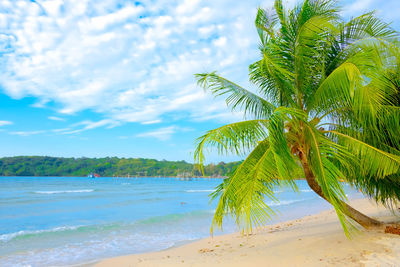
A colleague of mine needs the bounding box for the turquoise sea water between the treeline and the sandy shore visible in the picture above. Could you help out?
[0,177,360,266]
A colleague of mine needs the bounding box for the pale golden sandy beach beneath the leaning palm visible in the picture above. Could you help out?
[94,199,400,267]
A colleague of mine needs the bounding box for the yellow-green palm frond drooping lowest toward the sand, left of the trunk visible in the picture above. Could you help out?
[211,139,279,233]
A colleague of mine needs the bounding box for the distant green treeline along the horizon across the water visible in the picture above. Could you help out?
[0,156,240,177]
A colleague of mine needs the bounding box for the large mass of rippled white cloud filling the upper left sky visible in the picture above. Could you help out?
[0,0,259,127]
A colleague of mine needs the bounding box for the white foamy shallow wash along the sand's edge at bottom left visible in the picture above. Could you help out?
[0,230,195,266]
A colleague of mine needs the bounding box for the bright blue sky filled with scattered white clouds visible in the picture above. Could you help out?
[0,0,400,162]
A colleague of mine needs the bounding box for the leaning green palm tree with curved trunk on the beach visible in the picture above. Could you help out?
[195,0,400,234]
